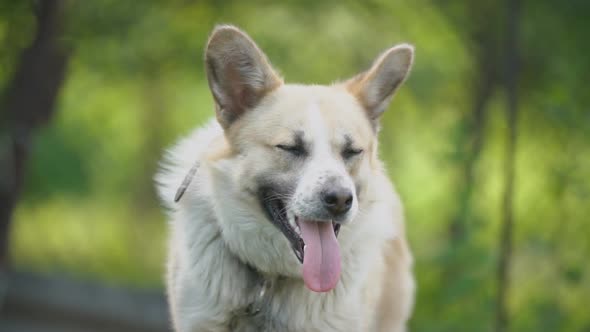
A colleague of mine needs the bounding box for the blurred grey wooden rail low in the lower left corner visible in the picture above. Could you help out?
[0,272,170,332]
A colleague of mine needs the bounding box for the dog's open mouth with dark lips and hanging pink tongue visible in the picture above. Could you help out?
[260,190,341,292]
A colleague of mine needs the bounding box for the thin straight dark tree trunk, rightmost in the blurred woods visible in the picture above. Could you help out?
[496,0,520,332]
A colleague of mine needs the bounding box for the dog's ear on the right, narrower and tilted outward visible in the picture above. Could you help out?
[345,44,414,126]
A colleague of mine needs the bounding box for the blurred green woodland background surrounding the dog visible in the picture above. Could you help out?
[0,0,590,332]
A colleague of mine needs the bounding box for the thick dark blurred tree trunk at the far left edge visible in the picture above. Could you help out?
[0,0,68,271]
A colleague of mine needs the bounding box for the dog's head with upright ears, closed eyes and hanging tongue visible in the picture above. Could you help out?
[205,26,413,291]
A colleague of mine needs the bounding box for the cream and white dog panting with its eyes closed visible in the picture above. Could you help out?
[156,25,415,332]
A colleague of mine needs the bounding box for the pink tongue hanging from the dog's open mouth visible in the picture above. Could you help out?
[299,220,340,292]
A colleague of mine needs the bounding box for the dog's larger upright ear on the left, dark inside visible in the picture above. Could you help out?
[205,25,283,128]
